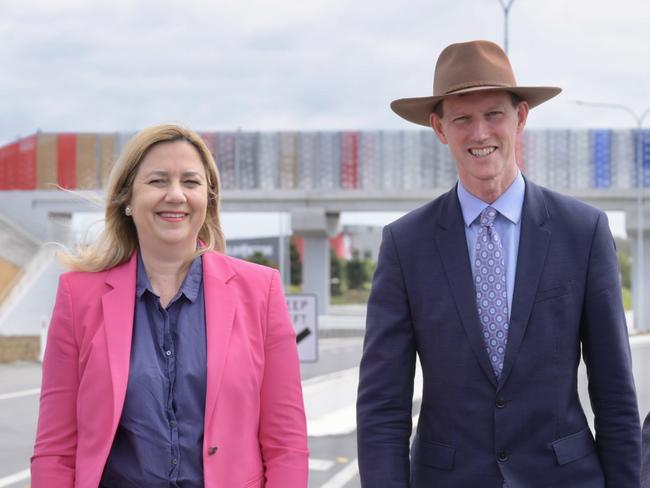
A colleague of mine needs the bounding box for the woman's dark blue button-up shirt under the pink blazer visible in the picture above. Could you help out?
[100,254,207,488]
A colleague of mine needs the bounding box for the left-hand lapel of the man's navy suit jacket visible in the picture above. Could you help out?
[436,188,496,387]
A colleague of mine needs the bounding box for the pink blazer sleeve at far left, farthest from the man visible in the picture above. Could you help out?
[31,274,79,488]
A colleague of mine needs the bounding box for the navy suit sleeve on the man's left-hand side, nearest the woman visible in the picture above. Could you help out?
[357,226,416,488]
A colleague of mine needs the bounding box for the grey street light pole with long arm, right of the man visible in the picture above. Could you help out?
[573,100,650,330]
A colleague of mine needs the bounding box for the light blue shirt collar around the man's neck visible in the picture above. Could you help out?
[457,171,526,227]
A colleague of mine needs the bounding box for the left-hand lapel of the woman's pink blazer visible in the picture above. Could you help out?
[102,252,137,427]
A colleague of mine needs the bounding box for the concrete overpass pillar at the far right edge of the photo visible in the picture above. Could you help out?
[625,208,650,331]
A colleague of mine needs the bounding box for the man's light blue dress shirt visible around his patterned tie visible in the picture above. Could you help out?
[457,172,526,316]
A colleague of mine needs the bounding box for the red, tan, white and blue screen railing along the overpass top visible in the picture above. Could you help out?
[0,129,650,191]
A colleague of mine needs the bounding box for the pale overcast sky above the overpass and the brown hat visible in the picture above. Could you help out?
[0,0,650,144]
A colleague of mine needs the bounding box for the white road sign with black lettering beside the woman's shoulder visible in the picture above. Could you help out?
[286,294,318,363]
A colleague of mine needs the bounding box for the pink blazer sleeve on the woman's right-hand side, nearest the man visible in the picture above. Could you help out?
[259,271,309,488]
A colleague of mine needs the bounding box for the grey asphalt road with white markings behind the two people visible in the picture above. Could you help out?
[0,332,650,488]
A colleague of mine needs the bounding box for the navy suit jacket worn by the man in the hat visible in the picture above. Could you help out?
[357,180,641,488]
